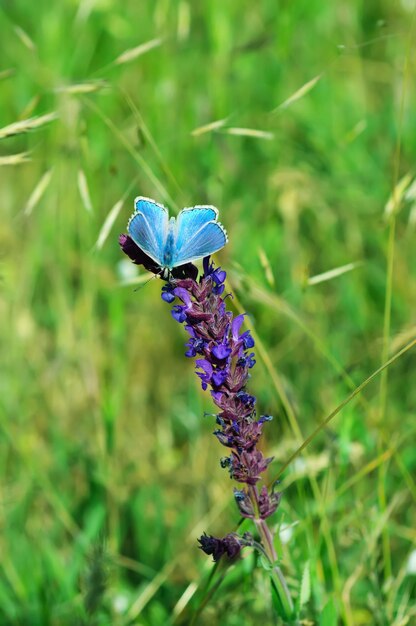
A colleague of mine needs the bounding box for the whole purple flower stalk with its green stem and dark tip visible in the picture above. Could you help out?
[119,235,297,624]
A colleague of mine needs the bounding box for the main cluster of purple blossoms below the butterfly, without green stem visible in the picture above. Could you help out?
[164,259,277,508]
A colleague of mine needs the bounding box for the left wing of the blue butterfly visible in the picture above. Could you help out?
[127,196,169,266]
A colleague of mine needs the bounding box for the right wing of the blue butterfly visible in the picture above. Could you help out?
[172,206,228,267]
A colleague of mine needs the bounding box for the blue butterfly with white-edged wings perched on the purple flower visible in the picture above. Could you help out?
[127,196,228,271]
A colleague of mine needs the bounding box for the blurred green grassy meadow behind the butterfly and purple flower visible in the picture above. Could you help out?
[0,0,416,626]
